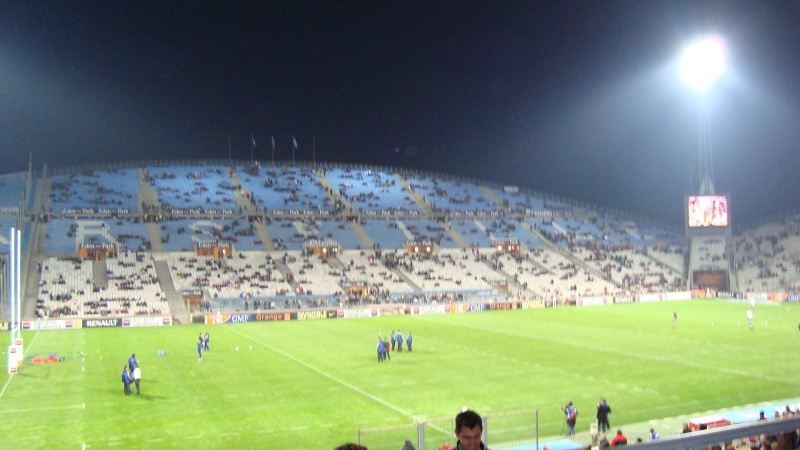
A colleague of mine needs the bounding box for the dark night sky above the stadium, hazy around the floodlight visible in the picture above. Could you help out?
[0,0,800,225]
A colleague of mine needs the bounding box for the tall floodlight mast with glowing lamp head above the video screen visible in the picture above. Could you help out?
[680,36,725,195]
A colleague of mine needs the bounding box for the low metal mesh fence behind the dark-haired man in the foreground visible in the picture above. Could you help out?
[358,409,539,450]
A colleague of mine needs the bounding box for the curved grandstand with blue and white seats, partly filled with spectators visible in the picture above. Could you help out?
[0,161,800,323]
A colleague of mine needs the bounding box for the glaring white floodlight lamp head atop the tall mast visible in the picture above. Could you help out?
[681,36,725,92]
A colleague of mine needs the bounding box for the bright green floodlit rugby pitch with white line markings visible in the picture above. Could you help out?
[0,300,800,449]
